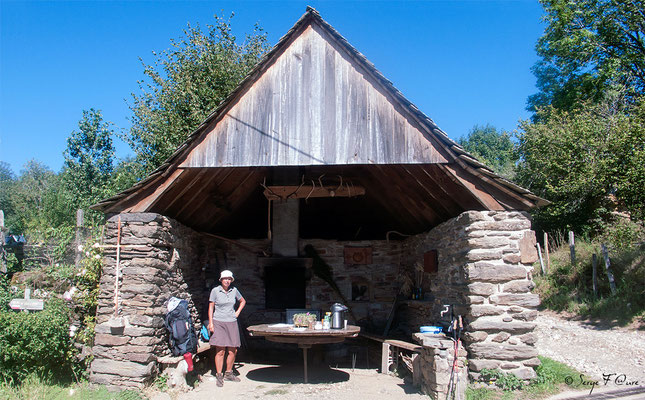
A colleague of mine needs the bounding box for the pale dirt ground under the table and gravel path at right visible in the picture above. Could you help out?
[146,312,645,400]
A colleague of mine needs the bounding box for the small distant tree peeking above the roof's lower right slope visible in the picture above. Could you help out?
[459,124,518,179]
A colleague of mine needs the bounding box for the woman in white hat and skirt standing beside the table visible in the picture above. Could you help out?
[208,270,246,387]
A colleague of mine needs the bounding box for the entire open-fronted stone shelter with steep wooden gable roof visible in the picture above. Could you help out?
[91,8,546,387]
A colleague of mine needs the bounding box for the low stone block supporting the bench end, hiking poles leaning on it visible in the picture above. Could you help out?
[413,333,468,400]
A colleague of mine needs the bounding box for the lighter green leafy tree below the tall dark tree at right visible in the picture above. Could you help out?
[517,94,645,234]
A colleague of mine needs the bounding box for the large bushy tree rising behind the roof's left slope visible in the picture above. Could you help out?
[125,15,268,172]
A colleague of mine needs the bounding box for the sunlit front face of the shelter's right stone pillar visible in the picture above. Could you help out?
[464,211,540,379]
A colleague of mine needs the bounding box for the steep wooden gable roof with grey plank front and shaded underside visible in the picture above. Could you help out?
[93,8,546,236]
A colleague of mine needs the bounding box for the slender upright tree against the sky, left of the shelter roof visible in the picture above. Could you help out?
[60,108,114,222]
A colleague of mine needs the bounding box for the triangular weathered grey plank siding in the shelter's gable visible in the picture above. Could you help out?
[181,24,447,167]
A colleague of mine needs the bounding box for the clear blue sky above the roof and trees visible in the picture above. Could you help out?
[0,0,544,173]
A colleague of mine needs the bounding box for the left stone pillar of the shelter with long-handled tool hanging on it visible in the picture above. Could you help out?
[90,213,207,390]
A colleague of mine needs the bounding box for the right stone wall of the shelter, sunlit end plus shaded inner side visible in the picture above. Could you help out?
[403,211,539,379]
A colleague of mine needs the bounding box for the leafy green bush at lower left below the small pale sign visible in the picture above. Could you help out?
[0,299,79,383]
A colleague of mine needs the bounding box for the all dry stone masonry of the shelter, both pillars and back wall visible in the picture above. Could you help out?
[91,211,539,390]
